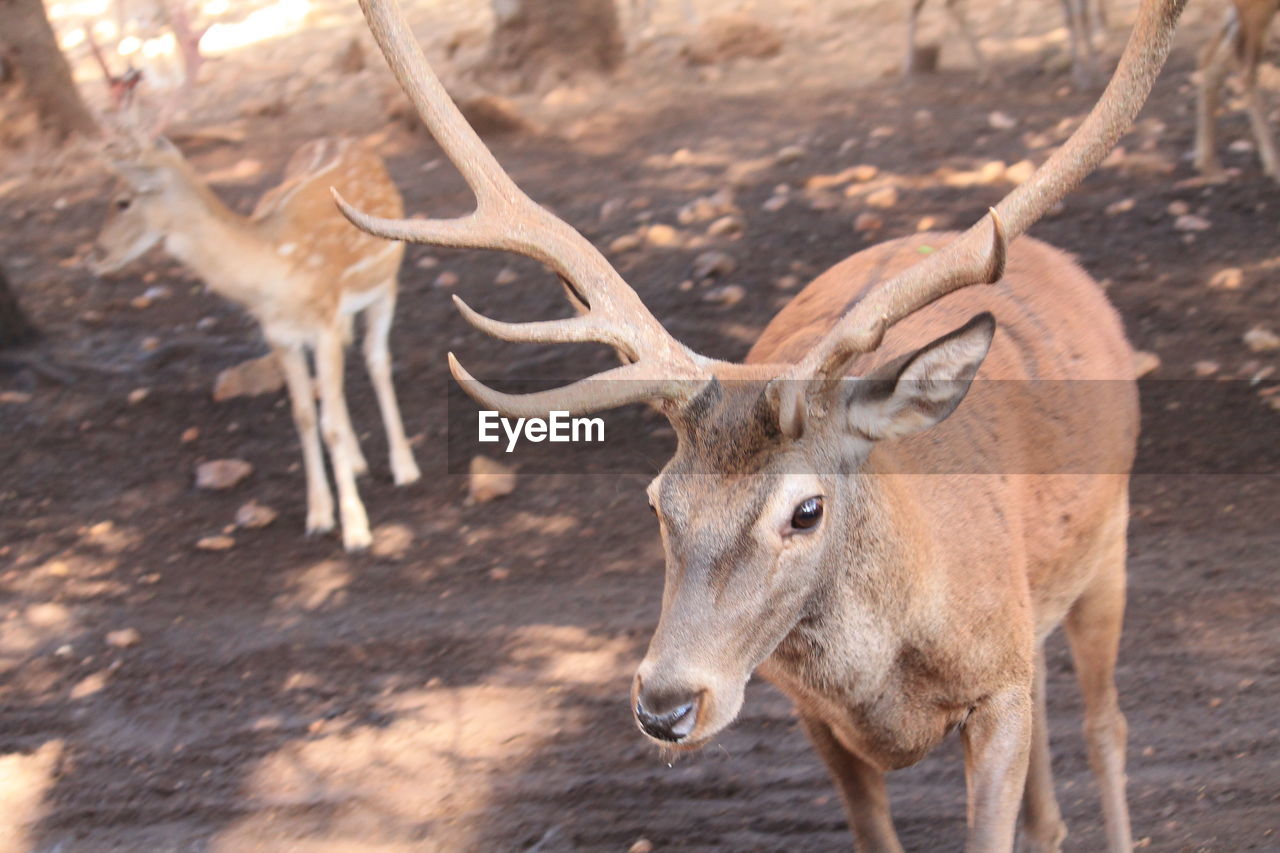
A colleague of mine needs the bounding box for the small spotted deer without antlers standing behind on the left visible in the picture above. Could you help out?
[88,133,420,551]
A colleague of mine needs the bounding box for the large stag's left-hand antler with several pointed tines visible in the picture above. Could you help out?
[334,0,712,416]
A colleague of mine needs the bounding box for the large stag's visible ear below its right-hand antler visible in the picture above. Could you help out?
[846,313,996,441]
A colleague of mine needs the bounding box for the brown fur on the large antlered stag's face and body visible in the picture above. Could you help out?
[635,234,1138,849]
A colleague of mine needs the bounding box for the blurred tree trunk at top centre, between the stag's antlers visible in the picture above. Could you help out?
[488,0,625,90]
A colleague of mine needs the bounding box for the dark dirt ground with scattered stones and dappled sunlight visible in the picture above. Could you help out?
[0,0,1280,853]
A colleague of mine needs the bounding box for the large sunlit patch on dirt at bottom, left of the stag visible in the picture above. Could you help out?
[218,685,577,853]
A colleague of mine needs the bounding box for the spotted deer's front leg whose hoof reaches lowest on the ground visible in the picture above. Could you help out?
[316,328,372,551]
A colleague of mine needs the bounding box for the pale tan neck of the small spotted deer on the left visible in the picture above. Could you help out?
[165,181,289,310]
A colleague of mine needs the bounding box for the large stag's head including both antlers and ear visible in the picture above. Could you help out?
[338,0,1183,747]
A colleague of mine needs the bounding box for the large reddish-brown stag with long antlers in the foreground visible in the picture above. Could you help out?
[334,0,1183,853]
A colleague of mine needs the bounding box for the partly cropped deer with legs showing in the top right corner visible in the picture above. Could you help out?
[1194,0,1280,181]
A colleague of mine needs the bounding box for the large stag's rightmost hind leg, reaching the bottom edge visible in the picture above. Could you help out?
[1064,532,1133,853]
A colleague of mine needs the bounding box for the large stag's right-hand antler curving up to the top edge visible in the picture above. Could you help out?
[794,0,1187,378]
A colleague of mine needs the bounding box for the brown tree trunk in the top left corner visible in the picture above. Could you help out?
[0,0,97,141]
